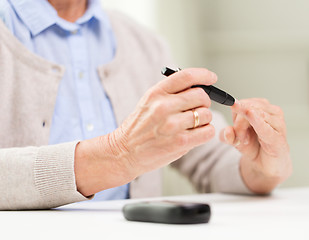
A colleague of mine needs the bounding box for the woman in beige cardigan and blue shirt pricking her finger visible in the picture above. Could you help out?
[0,0,292,209]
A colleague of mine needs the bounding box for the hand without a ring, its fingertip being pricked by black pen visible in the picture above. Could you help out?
[220,99,292,194]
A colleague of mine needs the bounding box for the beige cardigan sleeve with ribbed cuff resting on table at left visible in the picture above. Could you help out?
[0,142,87,210]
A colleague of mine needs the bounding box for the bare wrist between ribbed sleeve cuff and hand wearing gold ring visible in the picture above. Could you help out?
[74,129,135,196]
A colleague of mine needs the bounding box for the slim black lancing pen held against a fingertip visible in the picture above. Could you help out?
[161,67,235,106]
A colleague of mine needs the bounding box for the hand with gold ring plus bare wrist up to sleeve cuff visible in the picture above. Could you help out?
[75,69,217,196]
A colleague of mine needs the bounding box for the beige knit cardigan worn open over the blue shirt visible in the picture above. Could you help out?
[0,12,248,210]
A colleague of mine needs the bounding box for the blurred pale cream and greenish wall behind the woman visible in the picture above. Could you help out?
[102,0,309,194]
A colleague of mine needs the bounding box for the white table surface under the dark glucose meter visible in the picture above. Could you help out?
[0,188,309,240]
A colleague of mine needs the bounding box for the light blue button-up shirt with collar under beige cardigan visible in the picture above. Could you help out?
[1,0,128,200]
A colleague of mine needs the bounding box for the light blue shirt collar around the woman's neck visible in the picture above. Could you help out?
[10,0,109,36]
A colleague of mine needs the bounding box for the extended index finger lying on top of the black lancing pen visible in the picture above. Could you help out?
[159,68,217,94]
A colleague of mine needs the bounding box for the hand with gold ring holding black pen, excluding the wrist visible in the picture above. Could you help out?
[114,69,217,175]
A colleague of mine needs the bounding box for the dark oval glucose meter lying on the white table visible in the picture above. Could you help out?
[122,201,211,224]
